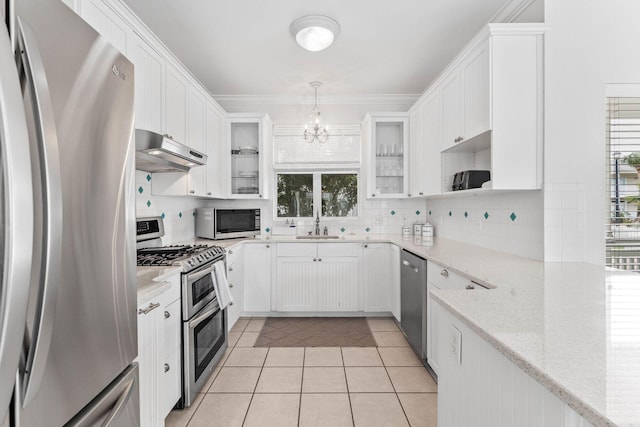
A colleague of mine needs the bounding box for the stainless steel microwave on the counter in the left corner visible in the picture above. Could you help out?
[196,208,260,240]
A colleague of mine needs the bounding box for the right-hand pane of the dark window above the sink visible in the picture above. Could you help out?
[322,174,358,216]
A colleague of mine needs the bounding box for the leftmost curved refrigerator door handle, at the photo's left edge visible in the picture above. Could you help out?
[0,29,33,420]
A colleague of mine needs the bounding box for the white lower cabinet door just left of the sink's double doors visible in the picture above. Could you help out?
[243,243,273,312]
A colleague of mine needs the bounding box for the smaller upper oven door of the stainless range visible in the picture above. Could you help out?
[182,263,216,320]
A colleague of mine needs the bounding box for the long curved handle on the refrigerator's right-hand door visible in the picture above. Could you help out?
[18,18,62,406]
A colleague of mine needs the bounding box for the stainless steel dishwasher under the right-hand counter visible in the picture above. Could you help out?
[400,250,427,361]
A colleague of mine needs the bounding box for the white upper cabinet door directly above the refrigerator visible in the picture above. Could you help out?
[77,0,129,54]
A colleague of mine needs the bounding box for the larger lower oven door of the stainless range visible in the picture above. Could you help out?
[182,299,227,407]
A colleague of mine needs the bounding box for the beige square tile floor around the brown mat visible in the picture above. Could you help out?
[165,318,437,427]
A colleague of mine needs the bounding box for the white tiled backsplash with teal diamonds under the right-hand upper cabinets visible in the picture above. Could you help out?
[426,191,544,260]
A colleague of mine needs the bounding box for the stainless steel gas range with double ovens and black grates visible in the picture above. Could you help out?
[136,217,228,407]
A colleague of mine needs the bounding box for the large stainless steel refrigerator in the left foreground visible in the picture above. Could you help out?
[0,0,140,427]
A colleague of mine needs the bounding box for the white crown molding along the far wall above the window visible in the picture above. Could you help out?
[213,93,422,106]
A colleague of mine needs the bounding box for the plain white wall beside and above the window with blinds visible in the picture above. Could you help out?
[544,0,640,264]
